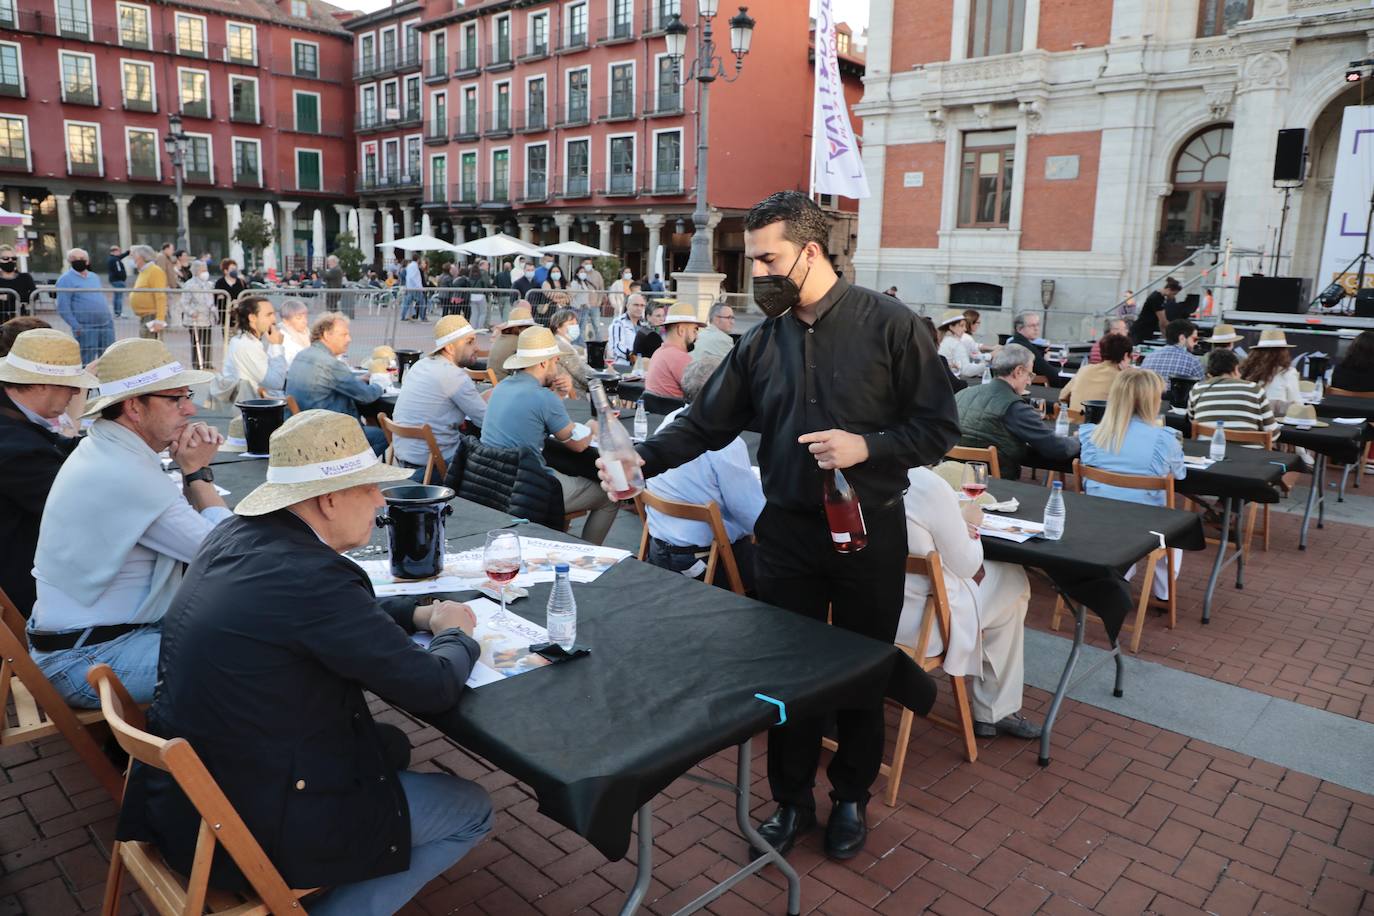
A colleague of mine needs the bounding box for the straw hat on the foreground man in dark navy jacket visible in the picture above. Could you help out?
[234,411,414,515]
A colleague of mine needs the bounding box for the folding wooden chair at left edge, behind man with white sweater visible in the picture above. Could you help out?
[0,589,124,802]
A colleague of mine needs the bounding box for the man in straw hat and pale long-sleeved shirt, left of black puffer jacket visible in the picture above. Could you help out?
[392,314,491,468]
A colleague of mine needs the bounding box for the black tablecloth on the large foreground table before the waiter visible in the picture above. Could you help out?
[430,526,936,860]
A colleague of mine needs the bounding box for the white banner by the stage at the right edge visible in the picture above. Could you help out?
[1315,106,1374,295]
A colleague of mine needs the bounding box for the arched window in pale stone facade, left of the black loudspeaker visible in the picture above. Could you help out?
[1154,125,1231,264]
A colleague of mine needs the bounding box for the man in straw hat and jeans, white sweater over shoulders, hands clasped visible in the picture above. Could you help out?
[29,338,229,709]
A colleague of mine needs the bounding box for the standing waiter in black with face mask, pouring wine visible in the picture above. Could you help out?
[612,191,959,858]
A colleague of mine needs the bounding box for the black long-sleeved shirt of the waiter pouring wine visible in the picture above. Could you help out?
[639,280,959,511]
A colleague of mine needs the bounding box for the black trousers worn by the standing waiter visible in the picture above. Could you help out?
[754,500,907,809]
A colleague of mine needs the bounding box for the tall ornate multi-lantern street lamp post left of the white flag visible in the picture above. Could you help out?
[664,0,754,273]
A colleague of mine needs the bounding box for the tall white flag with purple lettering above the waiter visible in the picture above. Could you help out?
[811,0,868,198]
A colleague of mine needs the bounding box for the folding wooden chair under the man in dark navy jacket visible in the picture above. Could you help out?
[87,665,317,916]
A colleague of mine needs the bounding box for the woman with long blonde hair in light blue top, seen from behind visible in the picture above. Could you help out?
[1079,367,1189,600]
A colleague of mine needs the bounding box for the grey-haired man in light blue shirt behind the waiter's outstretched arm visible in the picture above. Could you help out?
[647,357,764,592]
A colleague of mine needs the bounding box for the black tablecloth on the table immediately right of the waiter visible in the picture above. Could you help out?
[982,481,1206,640]
